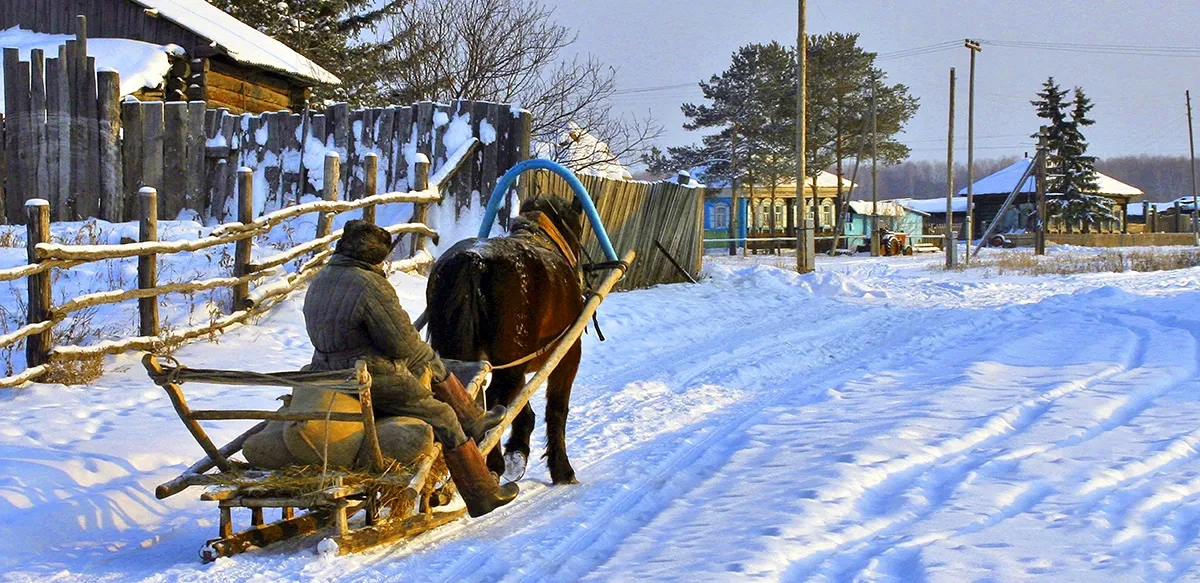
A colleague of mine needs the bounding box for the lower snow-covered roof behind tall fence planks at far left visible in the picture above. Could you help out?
[0,26,172,113]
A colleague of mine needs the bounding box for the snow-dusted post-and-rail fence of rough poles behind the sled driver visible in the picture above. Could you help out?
[0,138,479,387]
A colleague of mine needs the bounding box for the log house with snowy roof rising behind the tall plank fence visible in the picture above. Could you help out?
[0,0,341,113]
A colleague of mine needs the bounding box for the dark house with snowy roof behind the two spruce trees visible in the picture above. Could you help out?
[942,158,1145,235]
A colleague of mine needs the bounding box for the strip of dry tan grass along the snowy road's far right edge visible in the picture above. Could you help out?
[971,247,1200,275]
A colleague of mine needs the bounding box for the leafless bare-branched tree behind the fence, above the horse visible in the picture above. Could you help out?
[386,0,662,170]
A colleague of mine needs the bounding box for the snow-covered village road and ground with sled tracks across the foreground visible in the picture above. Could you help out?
[0,253,1200,582]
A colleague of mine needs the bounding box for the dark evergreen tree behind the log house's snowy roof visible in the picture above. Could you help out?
[208,0,422,107]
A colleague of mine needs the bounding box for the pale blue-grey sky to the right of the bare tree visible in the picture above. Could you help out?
[546,0,1200,161]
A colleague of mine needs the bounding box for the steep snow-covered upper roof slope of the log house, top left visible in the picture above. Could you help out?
[129,0,342,85]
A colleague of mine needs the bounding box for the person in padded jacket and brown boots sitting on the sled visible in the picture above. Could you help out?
[304,220,518,517]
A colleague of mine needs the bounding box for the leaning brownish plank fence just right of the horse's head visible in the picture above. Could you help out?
[528,170,704,289]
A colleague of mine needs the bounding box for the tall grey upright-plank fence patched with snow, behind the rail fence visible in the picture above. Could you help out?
[0,22,532,223]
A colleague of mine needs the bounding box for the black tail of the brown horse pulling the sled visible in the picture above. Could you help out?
[426,251,487,360]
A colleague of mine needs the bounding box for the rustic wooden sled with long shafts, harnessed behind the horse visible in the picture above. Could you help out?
[143,251,634,561]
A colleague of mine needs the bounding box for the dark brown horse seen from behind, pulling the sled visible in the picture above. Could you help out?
[426,197,583,483]
